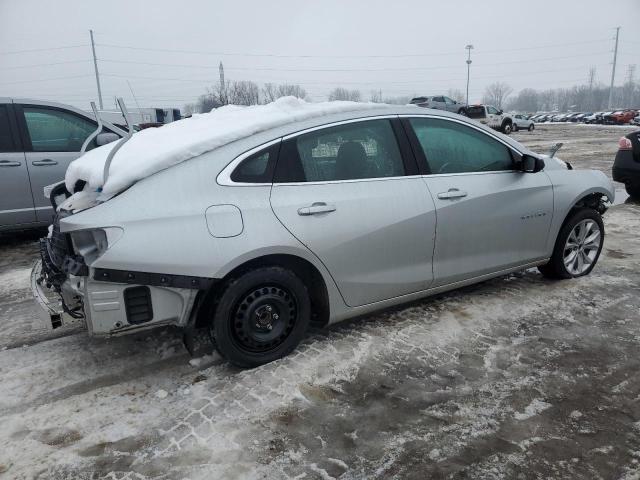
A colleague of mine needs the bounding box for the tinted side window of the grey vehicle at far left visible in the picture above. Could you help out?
[23,106,97,152]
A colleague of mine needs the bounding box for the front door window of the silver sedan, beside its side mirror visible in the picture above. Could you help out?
[409,118,514,174]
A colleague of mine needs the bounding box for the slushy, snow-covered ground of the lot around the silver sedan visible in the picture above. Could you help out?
[0,125,640,480]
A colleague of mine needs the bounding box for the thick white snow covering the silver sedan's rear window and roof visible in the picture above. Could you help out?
[65,97,380,196]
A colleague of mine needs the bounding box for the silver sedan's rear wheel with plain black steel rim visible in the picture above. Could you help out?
[209,267,311,368]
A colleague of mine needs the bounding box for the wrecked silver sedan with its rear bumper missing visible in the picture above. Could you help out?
[33,105,614,367]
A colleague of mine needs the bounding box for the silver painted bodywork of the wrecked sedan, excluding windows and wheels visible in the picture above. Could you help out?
[35,107,613,333]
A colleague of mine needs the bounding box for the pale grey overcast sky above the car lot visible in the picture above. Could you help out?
[0,0,640,108]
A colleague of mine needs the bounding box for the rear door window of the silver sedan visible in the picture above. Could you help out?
[276,120,405,182]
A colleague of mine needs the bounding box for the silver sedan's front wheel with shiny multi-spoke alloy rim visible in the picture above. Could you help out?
[538,208,604,279]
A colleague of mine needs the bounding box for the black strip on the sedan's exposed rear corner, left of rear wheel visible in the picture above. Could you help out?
[93,268,216,290]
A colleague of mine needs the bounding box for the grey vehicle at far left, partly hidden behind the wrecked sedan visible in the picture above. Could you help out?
[0,98,125,231]
